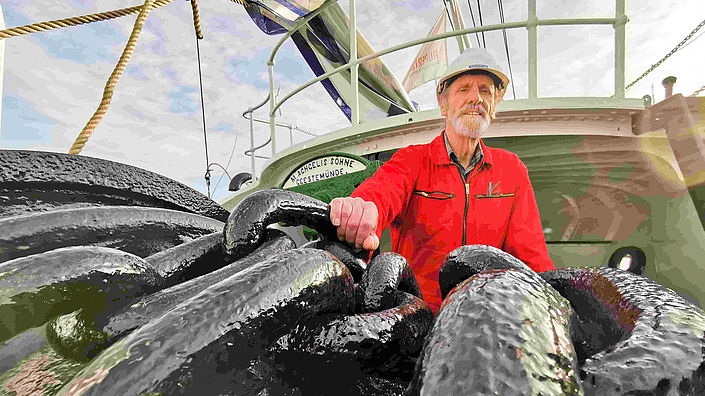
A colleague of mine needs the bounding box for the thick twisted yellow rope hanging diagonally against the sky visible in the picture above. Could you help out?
[69,0,159,154]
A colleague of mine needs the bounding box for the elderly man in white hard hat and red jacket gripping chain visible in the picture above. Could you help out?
[330,48,553,312]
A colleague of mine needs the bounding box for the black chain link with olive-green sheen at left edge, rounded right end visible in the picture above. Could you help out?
[0,246,164,341]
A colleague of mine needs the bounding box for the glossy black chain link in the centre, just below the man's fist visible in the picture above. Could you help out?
[280,253,433,395]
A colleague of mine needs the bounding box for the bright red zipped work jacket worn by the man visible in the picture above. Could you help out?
[351,133,553,312]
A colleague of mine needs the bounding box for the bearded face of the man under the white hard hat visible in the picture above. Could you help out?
[441,74,496,139]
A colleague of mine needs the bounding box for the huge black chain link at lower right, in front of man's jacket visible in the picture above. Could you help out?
[406,246,705,396]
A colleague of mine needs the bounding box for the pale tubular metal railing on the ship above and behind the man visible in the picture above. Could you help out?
[258,0,629,156]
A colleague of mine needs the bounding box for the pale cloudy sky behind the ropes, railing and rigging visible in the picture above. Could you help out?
[0,0,705,200]
